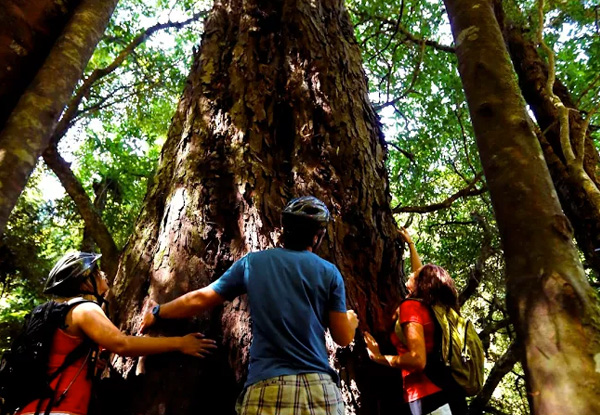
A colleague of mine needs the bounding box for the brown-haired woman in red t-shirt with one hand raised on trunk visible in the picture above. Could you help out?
[365,228,466,415]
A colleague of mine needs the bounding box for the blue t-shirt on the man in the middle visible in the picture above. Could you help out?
[209,248,346,386]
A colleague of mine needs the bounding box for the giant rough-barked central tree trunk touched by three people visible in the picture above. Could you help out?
[107,0,403,415]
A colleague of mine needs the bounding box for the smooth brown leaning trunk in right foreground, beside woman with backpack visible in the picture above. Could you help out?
[445,0,600,415]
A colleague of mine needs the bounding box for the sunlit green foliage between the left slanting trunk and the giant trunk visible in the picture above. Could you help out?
[0,0,207,352]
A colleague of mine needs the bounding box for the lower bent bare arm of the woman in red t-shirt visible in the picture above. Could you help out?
[365,323,427,372]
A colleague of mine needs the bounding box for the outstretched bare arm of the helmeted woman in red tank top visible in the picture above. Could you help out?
[72,303,216,357]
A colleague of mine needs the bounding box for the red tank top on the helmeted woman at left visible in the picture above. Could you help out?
[17,329,92,415]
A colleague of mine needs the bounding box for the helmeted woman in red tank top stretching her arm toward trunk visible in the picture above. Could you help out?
[17,252,216,415]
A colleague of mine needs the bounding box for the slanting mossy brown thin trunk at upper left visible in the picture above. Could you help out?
[0,0,117,234]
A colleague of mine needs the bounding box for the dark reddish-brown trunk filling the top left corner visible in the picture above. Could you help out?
[0,0,79,130]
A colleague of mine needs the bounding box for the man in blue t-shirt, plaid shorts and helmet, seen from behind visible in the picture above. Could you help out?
[142,196,358,415]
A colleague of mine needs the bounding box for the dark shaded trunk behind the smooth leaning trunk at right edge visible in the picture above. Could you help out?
[504,25,600,276]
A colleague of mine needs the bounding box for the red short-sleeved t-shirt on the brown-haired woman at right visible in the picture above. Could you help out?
[391,300,441,402]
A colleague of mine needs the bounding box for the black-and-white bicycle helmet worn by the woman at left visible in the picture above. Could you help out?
[44,252,102,297]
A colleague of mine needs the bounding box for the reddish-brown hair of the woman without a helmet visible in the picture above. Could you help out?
[409,264,460,312]
